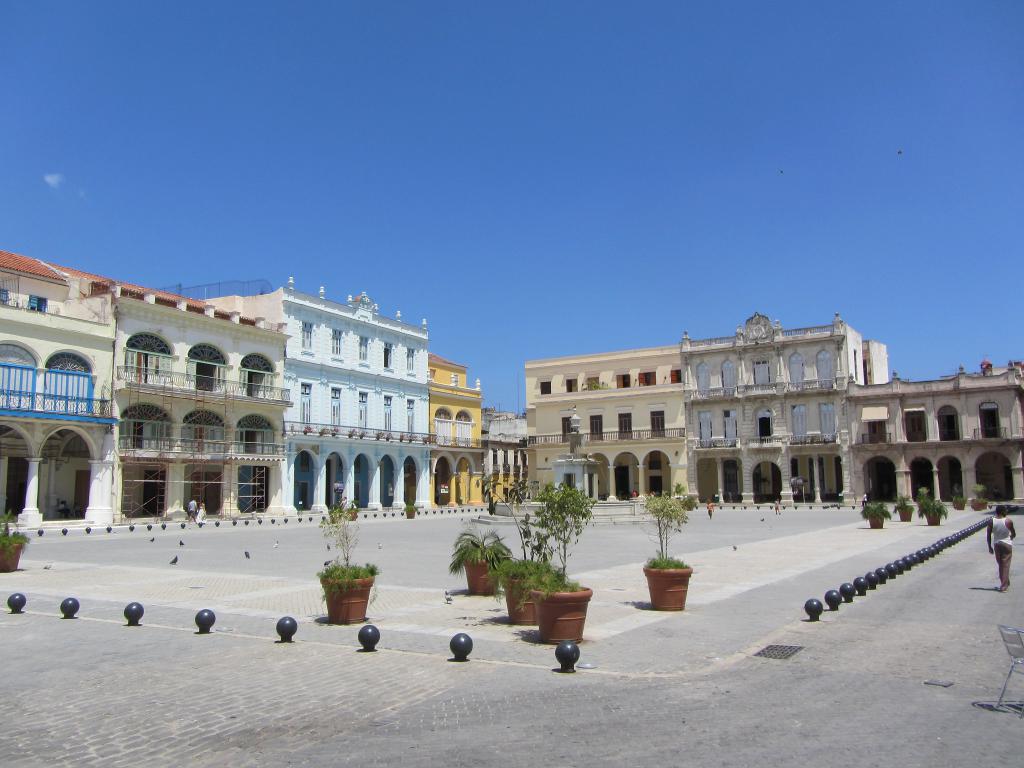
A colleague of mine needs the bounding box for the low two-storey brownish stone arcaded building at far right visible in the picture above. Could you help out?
[847,360,1024,502]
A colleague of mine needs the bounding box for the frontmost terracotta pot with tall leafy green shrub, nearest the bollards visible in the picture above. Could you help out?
[526,483,594,643]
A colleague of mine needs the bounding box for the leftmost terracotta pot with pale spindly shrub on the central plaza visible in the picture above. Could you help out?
[317,506,380,624]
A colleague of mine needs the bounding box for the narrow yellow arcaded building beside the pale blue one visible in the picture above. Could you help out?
[428,354,483,507]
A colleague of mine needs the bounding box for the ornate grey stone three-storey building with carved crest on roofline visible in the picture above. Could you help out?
[680,313,888,503]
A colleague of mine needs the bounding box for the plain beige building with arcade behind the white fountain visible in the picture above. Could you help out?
[525,345,686,500]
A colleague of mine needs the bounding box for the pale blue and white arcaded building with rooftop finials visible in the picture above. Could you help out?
[211,279,430,511]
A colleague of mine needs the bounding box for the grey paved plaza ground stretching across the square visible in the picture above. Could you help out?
[0,507,1024,766]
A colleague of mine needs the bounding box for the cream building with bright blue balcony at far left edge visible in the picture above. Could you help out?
[0,251,116,526]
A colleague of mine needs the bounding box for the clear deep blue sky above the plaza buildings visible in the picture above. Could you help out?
[0,0,1024,407]
